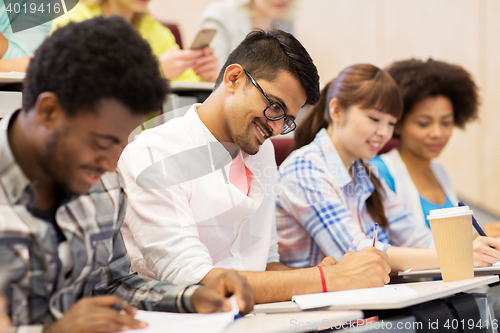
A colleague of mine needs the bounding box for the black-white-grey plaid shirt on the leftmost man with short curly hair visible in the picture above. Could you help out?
[0,113,194,332]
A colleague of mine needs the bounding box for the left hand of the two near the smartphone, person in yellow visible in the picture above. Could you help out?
[158,50,203,80]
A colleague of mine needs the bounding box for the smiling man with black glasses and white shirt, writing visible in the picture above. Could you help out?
[119,30,388,303]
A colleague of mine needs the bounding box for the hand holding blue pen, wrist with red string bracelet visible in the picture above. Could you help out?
[323,247,391,291]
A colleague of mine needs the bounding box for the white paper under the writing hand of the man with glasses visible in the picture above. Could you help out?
[292,285,418,310]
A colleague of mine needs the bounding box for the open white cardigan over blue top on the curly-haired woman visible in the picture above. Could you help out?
[380,149,458,225]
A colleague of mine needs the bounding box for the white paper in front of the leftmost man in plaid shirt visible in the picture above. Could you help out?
[120,295,239,333]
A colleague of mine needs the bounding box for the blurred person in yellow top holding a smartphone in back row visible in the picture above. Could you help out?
[52,0,219,82]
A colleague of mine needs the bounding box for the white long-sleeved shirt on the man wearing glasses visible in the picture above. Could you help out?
[118,104,279,284]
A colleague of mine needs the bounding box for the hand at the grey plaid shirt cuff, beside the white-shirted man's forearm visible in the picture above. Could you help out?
[191,270,255,314]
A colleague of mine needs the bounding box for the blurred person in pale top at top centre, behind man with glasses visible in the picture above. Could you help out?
[200,0,294,66]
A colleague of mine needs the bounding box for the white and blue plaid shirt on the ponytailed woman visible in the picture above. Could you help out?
[277,129,434,267]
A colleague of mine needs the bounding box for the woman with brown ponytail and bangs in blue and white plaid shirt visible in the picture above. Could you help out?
[277,64,500,271]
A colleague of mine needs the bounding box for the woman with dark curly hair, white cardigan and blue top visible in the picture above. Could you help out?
[370,59,500,237]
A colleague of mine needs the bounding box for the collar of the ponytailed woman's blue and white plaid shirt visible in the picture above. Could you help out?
[314,128,374,193]
